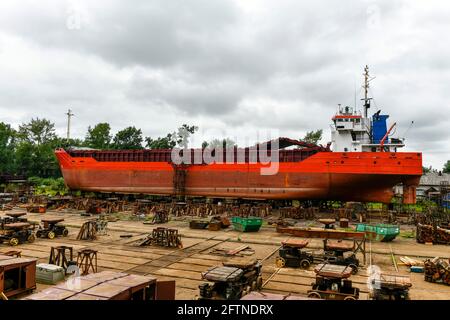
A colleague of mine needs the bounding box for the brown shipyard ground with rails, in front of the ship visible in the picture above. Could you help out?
[0,210,450,300]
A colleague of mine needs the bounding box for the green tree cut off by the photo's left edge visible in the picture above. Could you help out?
[0,122,16,174]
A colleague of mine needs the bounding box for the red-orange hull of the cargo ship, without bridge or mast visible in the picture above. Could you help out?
[55,150,422,204]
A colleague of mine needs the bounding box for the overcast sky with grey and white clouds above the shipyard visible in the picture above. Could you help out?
[0,0,450,169]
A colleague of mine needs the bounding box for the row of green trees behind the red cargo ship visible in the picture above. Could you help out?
[4,118,398,178]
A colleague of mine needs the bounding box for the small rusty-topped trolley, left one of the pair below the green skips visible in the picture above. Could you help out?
[275,239,314,269]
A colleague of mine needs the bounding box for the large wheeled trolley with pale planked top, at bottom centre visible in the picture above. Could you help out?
[199,258,262,300]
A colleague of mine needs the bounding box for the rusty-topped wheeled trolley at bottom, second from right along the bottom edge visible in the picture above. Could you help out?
[308,263,359,300]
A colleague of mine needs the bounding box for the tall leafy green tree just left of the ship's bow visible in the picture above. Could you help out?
[16,118,60,177]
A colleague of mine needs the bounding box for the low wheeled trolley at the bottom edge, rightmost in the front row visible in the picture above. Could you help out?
[369,274,412,300]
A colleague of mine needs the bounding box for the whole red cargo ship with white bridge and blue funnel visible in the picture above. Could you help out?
[55,66,422,204]
